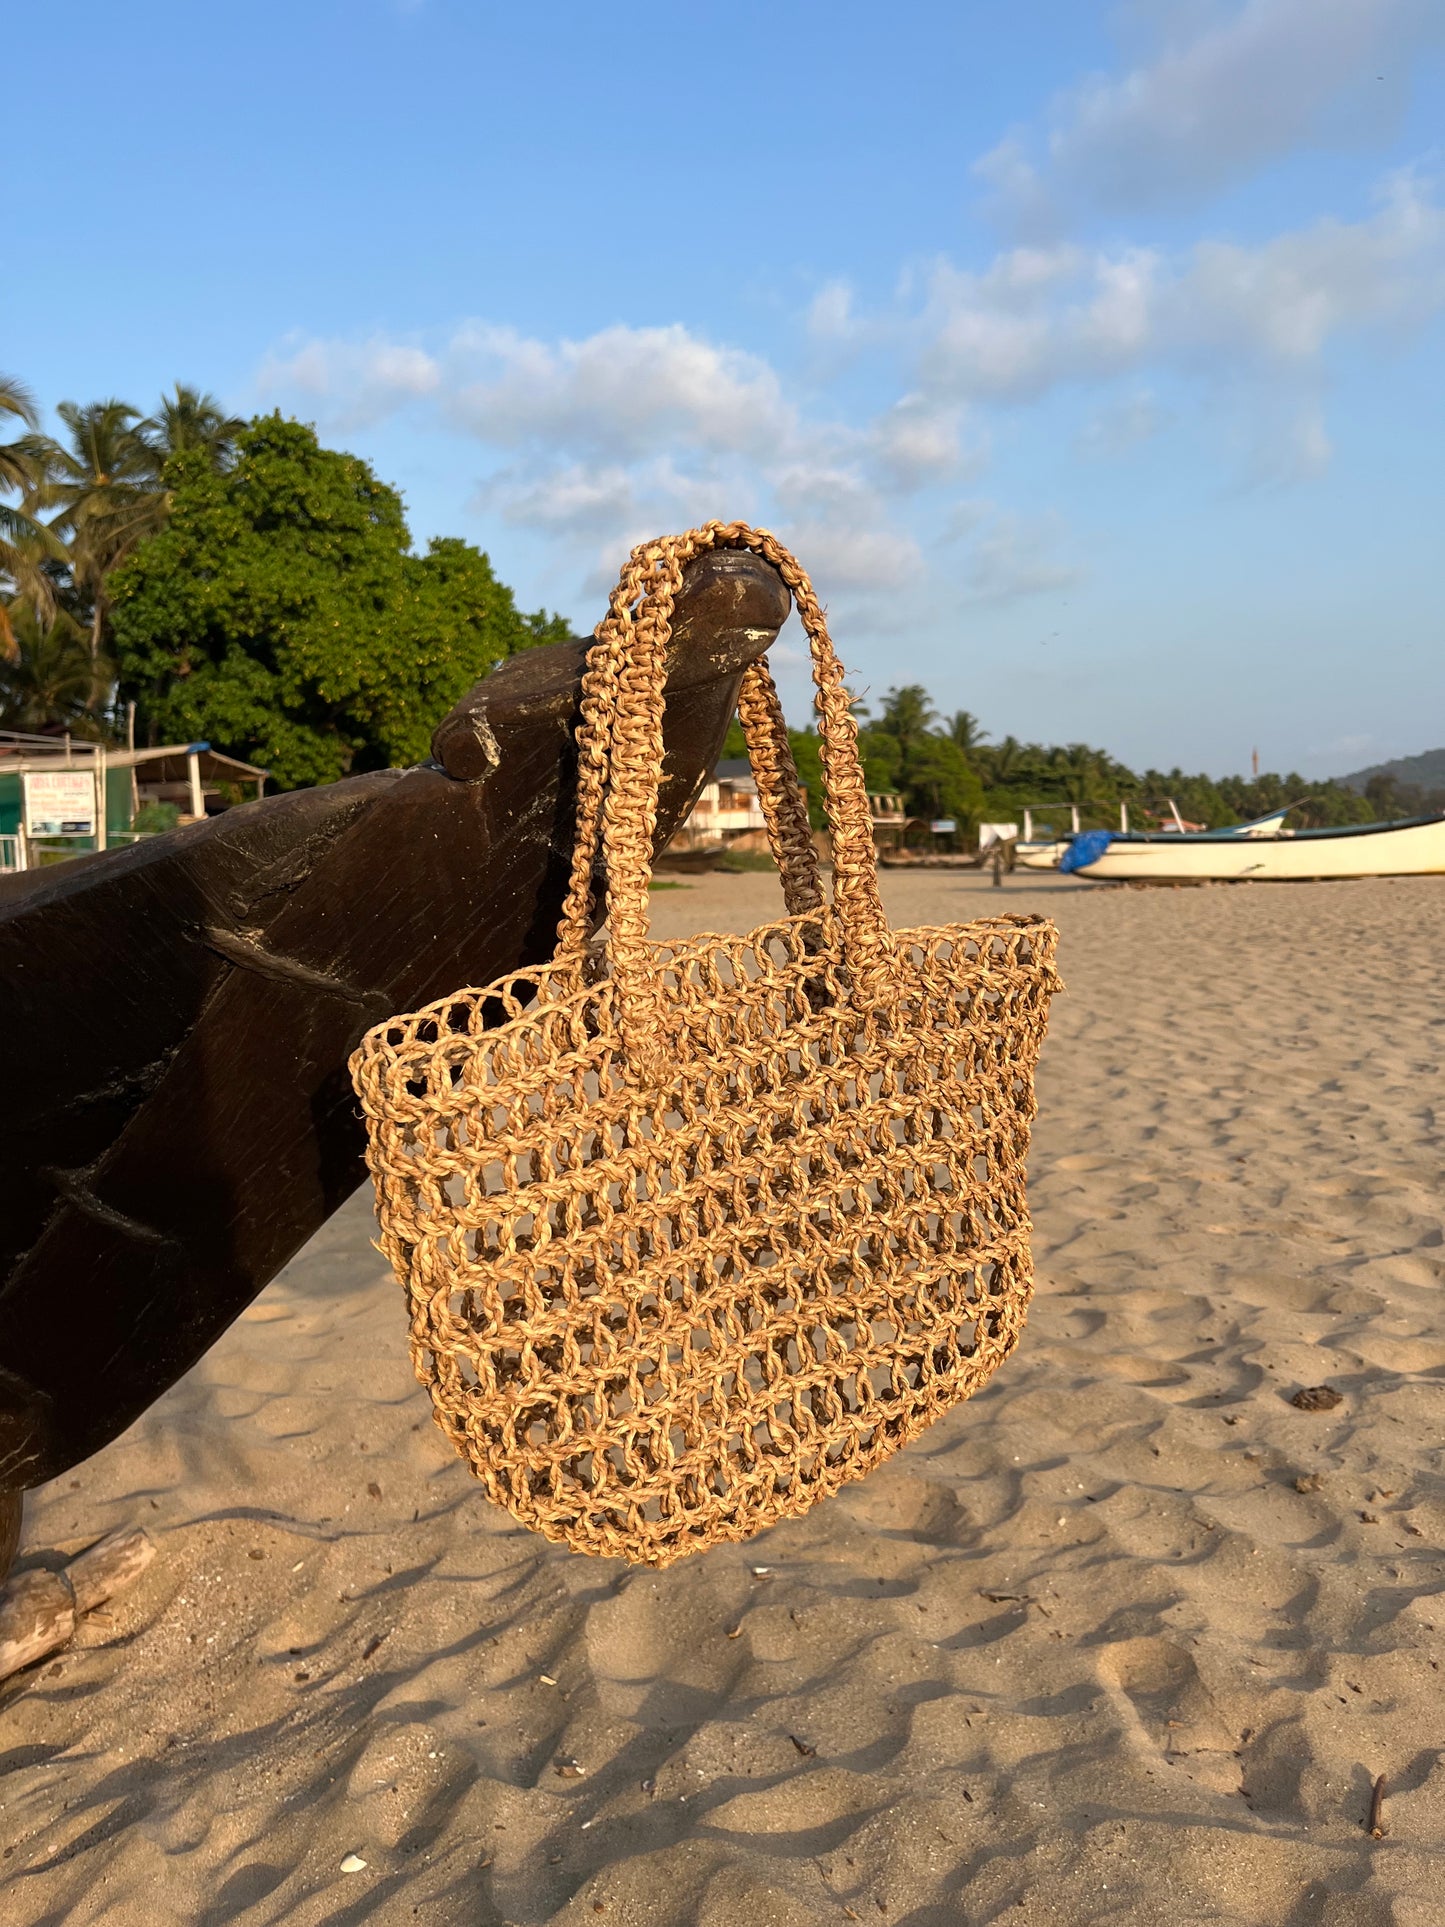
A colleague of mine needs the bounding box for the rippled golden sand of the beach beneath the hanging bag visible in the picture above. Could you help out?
[0,871,1445,1927]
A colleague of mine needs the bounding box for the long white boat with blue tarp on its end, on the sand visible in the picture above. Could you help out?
[1060,811,1445,883]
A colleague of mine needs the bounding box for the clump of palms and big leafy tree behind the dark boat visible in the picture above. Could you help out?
[0,378,568,788]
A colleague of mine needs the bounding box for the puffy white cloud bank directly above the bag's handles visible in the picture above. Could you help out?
[262,322,951,592]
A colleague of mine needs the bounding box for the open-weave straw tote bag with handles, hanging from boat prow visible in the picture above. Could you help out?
[351,522,1058,1567]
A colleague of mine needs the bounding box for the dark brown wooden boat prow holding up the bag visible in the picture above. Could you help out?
[0,553,788,1576]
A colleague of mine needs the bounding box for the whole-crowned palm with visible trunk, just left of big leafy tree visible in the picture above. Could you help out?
[35,401,166,661]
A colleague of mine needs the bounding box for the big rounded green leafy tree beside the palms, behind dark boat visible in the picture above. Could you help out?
[112,414,566,788]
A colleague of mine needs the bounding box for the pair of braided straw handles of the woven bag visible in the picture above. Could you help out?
[557,522,892,1077]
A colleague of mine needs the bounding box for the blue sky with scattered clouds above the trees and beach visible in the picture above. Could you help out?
[11,0,1445,775]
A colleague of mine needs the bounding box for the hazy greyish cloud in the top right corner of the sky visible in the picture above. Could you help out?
[975,0,1445,227]
